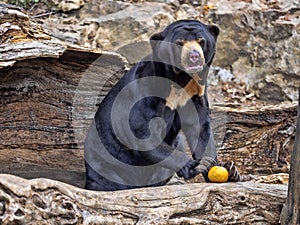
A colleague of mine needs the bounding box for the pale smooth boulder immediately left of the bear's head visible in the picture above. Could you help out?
[81,2,175,50]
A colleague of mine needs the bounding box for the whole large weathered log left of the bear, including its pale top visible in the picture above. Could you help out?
[0,5,126,186]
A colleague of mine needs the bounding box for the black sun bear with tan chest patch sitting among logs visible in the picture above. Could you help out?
[85,20,239,191]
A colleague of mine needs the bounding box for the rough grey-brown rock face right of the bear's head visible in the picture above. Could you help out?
[210,1,300,103]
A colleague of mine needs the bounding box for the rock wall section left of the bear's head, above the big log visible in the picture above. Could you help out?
[43,1,174,50]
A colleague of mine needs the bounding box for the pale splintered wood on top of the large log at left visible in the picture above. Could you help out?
[0,4,67,68]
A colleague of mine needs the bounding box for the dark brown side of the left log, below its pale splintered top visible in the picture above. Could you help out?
[0,50,124,185]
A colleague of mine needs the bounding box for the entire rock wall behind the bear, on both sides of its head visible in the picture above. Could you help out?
[39,0,300,103]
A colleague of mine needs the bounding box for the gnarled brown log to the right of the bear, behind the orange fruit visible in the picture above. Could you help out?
[215,103,297,175]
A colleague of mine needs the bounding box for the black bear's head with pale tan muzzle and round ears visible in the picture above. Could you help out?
[150,20,219,74]
